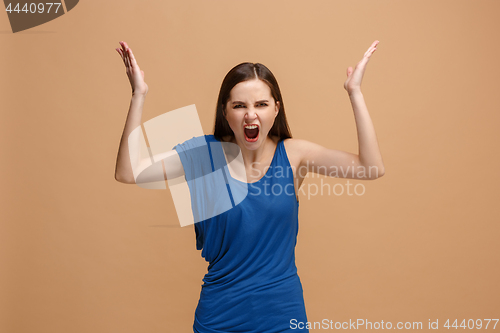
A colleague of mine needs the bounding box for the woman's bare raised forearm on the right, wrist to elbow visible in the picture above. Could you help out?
[349,90,385,177]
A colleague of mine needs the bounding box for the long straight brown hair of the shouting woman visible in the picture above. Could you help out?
[214,62,292,141]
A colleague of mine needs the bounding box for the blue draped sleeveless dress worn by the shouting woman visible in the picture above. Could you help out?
[174,135,308,333]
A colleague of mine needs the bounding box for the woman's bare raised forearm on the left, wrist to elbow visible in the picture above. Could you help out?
[115,94,146,184]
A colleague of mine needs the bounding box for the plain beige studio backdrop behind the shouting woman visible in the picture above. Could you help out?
[0,0,500,333]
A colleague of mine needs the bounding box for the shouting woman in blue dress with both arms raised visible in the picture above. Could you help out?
[115,41,384,333]
